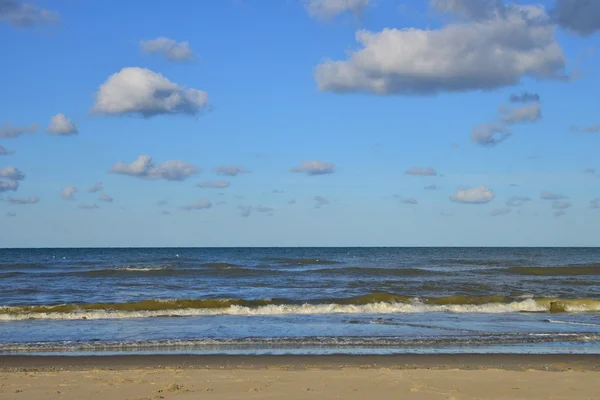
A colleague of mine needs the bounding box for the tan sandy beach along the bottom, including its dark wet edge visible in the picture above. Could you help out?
[0,355,600,400]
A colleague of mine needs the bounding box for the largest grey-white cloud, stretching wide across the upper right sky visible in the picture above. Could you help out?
[315,4,567,95]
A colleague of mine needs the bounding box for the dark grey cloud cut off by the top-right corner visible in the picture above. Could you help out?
[550,0,600,36]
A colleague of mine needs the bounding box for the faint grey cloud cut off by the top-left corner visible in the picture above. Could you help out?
[0,0,60,28]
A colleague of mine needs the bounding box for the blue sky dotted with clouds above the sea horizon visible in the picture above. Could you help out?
[0,0,600,247]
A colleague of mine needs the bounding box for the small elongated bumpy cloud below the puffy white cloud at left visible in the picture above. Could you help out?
[109,155,199,181]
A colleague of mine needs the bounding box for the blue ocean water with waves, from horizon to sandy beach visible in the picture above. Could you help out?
[0,248,600,355]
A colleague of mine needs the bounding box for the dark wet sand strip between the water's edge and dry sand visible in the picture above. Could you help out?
[0,354,600,372]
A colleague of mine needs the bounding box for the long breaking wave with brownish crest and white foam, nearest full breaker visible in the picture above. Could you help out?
[0,293,600,321]
